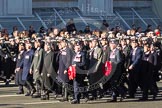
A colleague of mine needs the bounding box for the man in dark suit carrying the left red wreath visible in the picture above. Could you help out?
[71,42,85,104]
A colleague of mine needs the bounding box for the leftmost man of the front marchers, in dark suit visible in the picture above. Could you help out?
[15,43,25,94]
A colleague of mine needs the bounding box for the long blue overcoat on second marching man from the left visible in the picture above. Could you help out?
[21,49,34,81]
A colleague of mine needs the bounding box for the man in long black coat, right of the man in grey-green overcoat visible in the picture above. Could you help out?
[41,43,57,100]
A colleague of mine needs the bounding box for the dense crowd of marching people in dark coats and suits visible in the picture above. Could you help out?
[0,20,162,104]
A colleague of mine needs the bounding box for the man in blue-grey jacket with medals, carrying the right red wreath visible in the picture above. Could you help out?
[108,39,124,102]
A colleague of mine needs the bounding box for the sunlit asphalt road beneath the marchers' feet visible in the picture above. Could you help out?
[0,82,162,108]
